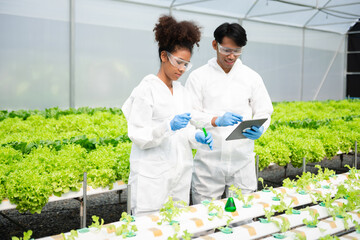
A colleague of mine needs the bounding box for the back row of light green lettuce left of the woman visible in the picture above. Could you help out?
[0,111,127,145]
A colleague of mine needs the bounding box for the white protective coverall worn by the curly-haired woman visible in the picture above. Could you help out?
[122,74,198,215]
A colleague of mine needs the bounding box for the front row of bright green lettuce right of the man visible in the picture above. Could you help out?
[255,118,360,169]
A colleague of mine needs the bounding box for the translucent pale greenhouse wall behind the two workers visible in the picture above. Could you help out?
[0,0,345,110]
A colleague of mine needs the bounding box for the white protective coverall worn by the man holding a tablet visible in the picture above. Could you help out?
[185,58,273,204]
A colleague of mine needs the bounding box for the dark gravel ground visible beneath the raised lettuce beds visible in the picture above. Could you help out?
[0,155,360,240]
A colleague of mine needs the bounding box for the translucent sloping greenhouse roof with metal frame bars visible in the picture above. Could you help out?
[122,0,360,34]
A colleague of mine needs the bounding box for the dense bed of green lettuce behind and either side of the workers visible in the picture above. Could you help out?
[0,100,360,212]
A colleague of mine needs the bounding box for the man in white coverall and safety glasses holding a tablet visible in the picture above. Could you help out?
[186,23,273,204]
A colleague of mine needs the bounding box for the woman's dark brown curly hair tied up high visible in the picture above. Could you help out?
[153,15,201,56]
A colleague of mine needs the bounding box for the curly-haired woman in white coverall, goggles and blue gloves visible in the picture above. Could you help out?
[122,16,212,216]
